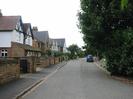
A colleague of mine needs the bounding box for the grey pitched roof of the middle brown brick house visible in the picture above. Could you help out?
[33,31,49,43]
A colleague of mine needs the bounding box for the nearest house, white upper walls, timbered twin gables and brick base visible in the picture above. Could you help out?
[0,12,40,57]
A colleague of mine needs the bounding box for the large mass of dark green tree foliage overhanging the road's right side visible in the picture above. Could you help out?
[78,0,133,75]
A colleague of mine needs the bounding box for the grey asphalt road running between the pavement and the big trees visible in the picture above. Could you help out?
[23,59,133,99]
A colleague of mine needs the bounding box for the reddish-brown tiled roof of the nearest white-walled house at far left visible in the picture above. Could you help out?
[0,16,21,31]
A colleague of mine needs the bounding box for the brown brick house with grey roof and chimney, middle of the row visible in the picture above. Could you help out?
[33,27,50,53]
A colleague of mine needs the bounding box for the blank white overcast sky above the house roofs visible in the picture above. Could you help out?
[0,0,84,47]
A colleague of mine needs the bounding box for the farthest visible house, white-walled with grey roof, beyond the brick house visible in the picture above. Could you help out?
[52,38,67,53]
